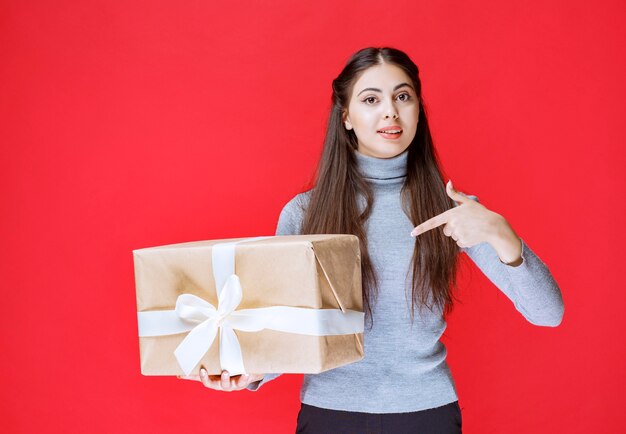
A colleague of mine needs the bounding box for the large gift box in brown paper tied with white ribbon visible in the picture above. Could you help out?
[133,235,364,375]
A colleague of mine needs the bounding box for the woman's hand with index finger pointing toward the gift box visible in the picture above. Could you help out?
[411,181,522,266]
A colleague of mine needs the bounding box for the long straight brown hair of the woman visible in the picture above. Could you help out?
[301,47,459,324]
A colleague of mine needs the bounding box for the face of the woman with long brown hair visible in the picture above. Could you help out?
[343,63,419,158]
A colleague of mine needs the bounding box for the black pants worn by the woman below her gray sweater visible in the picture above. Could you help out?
[296,401,461,434]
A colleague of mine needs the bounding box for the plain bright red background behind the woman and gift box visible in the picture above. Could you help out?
[0,0,626,433]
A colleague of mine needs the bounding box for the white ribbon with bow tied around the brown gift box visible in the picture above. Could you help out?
[137,237,364,375]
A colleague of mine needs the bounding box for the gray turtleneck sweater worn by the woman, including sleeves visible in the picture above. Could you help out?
[248,151,564,413]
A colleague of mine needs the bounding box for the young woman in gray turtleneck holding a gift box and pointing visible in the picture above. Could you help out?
[179,48,564,434]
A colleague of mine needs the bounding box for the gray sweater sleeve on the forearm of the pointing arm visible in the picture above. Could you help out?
[461,196,564,327]
